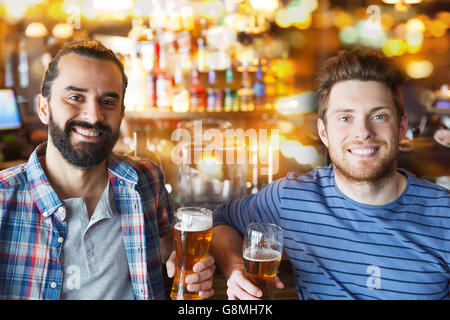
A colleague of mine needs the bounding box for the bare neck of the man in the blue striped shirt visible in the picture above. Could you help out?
[334,169,408,206]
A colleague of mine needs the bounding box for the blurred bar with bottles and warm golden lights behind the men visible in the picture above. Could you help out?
[0,0,450,207]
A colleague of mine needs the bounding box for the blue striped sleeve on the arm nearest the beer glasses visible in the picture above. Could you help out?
[213,178,285,235]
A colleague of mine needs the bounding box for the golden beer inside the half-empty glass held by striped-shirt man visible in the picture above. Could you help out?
[243,248,281,300]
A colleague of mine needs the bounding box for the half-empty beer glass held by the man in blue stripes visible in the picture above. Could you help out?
[243,223,283,300]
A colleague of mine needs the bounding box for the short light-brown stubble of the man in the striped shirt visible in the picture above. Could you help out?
[328,142,398,183]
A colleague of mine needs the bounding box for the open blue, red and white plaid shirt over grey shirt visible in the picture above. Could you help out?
[0,144,173,300]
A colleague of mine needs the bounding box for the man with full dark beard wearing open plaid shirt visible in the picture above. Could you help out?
[0,40,215,300]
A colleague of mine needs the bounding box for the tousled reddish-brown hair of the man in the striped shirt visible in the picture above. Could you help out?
[315,49,405,124]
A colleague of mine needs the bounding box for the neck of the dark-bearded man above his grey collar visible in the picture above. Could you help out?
[41,143,108,199]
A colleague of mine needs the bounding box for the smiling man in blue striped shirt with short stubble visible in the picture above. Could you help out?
[211,49,450,299]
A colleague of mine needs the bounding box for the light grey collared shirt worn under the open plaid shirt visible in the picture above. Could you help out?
[58,182,135,300]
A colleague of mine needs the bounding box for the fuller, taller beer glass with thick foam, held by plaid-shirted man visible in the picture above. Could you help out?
[170,207,212,300]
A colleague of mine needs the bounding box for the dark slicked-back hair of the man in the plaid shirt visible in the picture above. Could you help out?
[41,40,128,107]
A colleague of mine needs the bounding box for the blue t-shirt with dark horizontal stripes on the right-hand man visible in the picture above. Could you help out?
[214,165,450,300]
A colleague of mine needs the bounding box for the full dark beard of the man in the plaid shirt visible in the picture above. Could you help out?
[48,112,120,169]
